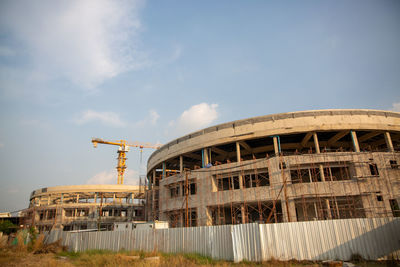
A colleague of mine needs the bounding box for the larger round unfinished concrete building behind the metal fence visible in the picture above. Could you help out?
[146,110,400,227]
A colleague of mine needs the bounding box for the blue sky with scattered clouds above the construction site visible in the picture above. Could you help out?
[0,0,400,212]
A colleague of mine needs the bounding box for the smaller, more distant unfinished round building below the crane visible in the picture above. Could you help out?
[24,185,145,232]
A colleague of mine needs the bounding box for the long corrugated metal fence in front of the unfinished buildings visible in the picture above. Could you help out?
[46,218,400,262]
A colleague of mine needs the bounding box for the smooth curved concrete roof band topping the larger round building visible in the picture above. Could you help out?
[147,109,400,171]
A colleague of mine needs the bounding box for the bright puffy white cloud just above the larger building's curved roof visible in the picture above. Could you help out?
[169,103,219,134]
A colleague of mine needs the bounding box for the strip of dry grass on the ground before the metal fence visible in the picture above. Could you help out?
[0,249,394,267]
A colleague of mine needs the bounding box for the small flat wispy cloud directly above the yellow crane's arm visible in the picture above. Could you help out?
[74,110,126,127]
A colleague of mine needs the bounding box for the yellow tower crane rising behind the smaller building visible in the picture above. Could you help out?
[92,138,161,184]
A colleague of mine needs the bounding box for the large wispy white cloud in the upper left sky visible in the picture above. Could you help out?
[0,0,147,88]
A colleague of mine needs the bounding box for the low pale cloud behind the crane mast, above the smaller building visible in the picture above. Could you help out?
[86,169,144,185]
